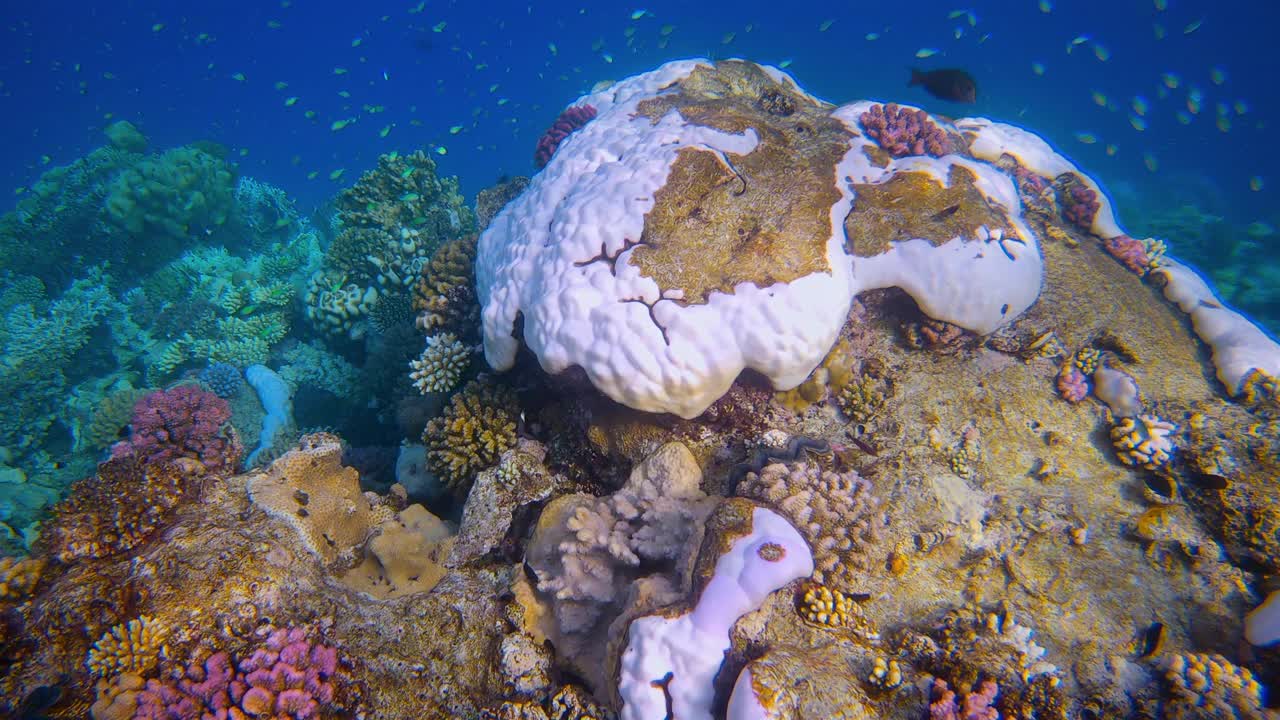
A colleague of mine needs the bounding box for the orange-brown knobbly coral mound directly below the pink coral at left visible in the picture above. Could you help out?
[37,456,197,562]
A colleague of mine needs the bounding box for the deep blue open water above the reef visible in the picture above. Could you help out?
[0,0,1280,220]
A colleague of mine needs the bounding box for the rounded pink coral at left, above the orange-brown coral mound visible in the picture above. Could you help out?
[111,386,242,471]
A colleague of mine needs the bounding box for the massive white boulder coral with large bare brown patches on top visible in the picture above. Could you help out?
[476,60,1041,418]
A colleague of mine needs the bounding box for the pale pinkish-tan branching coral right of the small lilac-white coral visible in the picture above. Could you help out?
[737,462,884,588]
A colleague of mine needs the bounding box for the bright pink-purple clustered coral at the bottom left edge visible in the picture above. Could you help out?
[133,628,338,720]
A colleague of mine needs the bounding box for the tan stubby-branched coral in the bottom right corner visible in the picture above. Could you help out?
[1157,652,1267,720]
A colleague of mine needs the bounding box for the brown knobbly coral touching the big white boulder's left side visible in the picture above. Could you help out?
[413,236,480,337]
